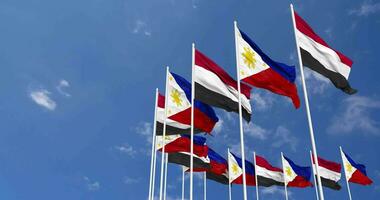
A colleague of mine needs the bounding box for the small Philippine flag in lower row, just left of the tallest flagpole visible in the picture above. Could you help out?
[282,156,312,188]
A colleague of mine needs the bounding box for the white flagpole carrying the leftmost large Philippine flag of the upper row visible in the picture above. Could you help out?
[160,67,169,200]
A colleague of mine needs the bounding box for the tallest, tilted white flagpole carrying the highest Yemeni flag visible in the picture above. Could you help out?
[290,4,325,200]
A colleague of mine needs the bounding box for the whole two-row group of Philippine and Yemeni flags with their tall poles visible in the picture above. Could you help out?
[150,6,366,200]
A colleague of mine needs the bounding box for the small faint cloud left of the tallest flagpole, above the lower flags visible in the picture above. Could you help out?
[272,126,298,151]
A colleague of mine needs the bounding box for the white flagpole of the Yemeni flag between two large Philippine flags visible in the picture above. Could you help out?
[189,43,195,200]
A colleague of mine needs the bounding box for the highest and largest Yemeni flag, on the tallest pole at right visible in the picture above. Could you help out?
[293,12,357,94]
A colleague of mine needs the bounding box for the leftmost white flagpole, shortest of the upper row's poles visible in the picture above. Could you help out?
[148,88,158,200]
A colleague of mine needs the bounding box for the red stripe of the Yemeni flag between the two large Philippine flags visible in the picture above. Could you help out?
[195,49,251,99]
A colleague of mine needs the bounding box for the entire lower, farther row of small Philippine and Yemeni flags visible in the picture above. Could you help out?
[157,135,372,190]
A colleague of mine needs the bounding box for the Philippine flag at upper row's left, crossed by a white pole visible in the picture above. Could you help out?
[157,72,219,135]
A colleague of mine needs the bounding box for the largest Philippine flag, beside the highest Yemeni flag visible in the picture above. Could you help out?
[236,29,300,108]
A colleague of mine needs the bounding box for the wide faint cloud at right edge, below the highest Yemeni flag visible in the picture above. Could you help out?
[327,95,380,135]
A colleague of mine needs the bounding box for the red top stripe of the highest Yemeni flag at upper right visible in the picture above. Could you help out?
[294,11,353,67]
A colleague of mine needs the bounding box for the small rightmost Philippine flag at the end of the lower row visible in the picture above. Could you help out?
[342,151,372,185]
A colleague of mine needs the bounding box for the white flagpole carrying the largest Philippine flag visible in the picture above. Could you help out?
[234,21,247,200]
